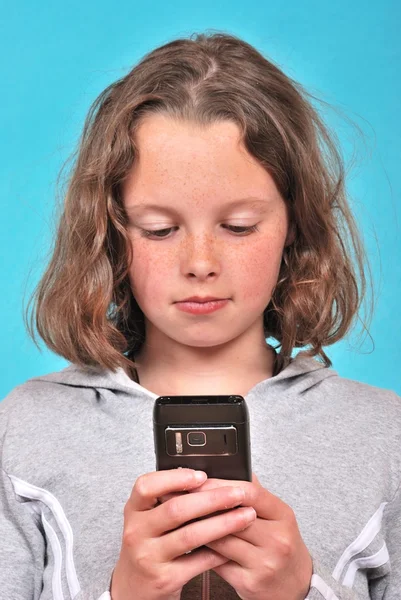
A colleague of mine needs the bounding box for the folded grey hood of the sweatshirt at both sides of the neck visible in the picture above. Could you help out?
[26,352,337,398]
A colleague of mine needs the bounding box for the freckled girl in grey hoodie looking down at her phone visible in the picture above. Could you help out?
[0,33,401,600]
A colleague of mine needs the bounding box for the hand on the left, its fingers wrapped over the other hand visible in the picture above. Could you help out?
[110,469,256,600]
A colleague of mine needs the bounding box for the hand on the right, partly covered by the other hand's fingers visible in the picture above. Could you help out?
[191,474,313,600]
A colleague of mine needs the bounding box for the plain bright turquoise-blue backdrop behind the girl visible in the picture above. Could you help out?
[0,0,401,398]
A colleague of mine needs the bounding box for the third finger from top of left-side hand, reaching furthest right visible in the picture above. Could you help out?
[162,507,256,562]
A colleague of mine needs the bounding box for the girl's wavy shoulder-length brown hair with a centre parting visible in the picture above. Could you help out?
[25,33,366,377]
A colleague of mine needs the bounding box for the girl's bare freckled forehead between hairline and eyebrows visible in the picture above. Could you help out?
[123,115,278,201]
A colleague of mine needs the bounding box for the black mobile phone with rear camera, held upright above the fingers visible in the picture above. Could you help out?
[153,395,252,481]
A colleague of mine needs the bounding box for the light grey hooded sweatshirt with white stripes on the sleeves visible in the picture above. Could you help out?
[0,354,401,600]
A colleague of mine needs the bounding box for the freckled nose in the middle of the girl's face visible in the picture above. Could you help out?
[181,235,221,280]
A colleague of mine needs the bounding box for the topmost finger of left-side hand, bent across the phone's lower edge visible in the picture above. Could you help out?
[127,469,207,511]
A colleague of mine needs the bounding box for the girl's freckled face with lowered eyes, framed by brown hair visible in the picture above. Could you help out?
[123,115,288,348]
